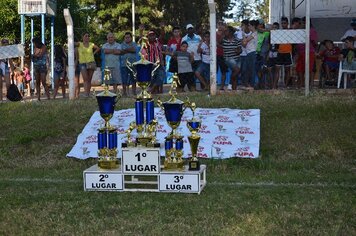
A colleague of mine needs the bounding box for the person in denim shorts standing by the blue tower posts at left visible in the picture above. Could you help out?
[32,38,50,101]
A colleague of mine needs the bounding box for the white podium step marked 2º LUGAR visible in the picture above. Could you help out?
[83,165,123,191]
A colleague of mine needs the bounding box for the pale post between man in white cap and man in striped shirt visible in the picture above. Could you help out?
[208,0,216,95]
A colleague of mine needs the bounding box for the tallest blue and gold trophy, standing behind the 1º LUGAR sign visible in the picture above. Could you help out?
[126,37,160,146]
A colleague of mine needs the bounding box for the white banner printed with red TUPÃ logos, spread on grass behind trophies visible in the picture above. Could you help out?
[67,108,260,159]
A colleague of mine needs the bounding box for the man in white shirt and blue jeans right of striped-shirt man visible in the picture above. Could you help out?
[242,20,258,89]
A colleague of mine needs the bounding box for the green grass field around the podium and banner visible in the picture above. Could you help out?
[0,92,356,235]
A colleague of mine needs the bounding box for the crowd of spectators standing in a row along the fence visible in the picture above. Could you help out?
[0,17,356,101]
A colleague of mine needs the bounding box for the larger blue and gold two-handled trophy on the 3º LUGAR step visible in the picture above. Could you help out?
[157,74,191,170]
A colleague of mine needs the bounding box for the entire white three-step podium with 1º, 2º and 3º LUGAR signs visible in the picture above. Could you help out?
[83,147,207,194]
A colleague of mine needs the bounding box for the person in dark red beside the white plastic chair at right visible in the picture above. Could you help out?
[318,39,340,84]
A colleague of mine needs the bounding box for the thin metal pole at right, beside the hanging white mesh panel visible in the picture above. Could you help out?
[305,0,310,96]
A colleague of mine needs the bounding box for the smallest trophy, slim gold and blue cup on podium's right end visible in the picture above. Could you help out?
[187,103,201,170]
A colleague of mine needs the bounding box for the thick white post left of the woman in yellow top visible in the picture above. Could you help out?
[63,8,75,99]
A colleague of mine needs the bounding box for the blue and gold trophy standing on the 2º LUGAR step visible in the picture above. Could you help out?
[96,69,120,169]
